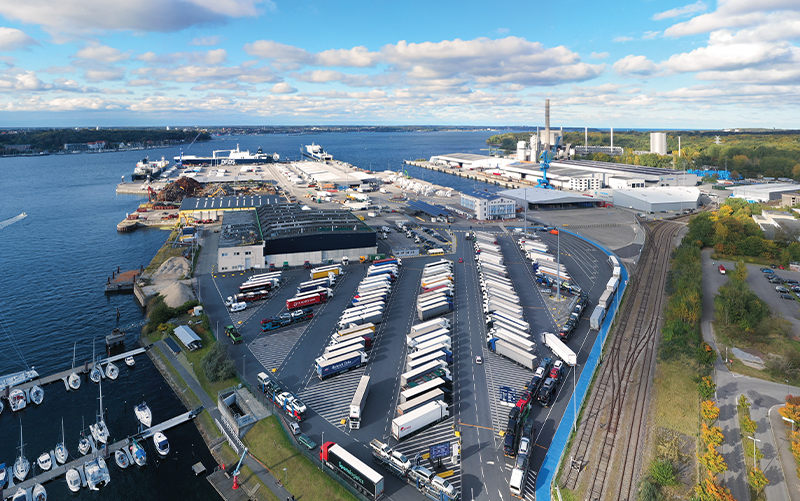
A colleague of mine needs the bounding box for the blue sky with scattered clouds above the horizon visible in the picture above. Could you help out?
[0,0,800,129]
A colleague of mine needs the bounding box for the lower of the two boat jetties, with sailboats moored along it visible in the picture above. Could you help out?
[3,406,203,499]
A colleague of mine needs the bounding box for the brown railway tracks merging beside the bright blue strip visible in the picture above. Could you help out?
[562,218,684,501]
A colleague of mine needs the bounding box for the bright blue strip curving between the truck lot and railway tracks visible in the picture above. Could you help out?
[536,229,628,501]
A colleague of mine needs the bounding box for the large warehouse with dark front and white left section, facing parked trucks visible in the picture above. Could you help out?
[217,203,378,271]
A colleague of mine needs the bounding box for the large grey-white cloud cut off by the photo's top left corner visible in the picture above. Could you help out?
[0,0,274,34]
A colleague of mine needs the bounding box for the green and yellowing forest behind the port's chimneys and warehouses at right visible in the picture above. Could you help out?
[486,130,800,180]
